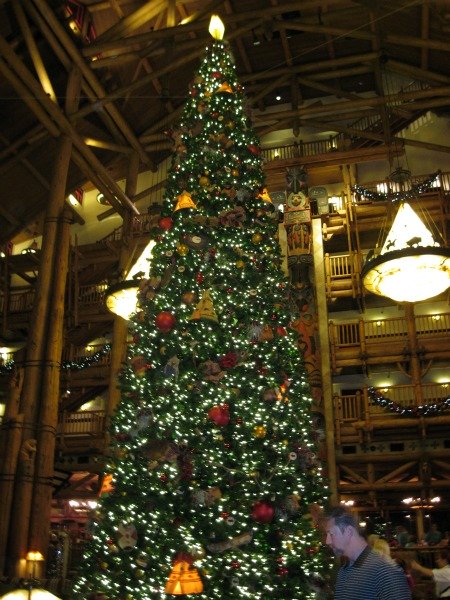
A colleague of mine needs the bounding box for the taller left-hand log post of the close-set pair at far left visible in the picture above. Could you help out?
[6,135,72,577]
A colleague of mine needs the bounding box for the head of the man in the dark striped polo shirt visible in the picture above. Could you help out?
[325,506,367,560]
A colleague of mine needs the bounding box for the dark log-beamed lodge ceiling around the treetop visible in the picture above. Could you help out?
[0,0,450,243]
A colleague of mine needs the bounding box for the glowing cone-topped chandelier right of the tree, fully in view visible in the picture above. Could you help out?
[361,202,450,302]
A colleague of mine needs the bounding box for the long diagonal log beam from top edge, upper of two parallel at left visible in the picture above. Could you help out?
[33,0,150,164]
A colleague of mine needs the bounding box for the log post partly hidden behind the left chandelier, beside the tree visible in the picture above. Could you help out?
[106,153,139,422]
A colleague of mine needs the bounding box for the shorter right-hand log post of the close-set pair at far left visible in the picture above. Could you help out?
[28,207,71,557]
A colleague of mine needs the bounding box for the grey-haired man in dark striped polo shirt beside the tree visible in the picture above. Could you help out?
[325,506,411,600]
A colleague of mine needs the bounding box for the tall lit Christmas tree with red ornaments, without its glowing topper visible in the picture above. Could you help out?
[74,18,329,600]
